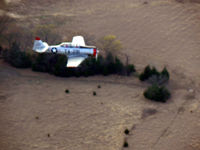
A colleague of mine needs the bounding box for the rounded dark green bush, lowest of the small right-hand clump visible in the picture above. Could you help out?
[144,84,171,102]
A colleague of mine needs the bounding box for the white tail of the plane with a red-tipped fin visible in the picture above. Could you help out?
[33,37,49,53]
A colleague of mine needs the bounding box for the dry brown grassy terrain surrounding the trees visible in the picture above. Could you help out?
[0,0,200,150]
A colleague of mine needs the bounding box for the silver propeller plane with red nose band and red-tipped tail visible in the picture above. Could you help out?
[33,36,99,67]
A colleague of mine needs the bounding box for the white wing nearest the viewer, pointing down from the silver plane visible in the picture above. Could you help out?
[66,55,88,68]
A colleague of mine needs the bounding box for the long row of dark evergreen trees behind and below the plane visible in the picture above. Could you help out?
[0,42,135,77]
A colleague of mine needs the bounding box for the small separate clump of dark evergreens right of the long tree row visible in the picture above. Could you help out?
[139,65,171,102]
